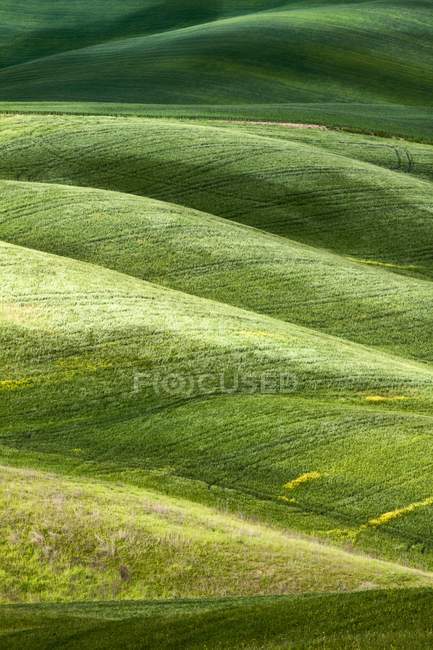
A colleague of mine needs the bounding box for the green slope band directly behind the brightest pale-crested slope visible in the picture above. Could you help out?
[0,181,433,361]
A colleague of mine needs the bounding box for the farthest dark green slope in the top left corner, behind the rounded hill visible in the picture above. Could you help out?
[0,0,284,67]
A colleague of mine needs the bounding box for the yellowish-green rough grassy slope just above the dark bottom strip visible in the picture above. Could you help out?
[0,467,433,603]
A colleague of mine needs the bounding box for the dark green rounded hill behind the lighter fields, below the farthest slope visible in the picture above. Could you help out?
[0,0,433,105]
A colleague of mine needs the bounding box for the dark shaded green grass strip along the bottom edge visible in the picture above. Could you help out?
[0,590,433,650]
